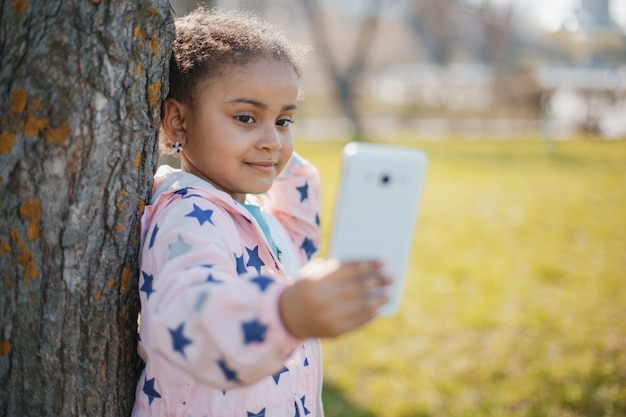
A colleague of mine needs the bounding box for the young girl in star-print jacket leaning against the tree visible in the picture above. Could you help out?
[133,9,389,417]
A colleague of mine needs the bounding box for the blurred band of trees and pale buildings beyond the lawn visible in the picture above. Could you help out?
[171,0,626,139]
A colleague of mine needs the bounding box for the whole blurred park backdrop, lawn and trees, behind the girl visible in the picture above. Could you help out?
[172,0,626,417]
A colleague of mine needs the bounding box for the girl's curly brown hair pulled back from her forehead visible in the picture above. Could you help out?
[168,7,304,105]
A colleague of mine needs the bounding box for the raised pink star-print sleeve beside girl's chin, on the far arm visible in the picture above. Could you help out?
[261,152,322,264]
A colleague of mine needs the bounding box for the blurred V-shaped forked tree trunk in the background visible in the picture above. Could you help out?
[302,0,382,140]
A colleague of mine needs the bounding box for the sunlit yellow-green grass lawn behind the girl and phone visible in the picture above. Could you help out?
[297,140,626,417]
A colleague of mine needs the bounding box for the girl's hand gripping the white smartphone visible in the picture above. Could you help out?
[280,259,391,339]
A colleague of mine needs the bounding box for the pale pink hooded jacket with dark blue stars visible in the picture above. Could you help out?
[133,154,323,417]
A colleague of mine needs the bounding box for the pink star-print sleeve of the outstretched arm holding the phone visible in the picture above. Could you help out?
[139,195,301,389]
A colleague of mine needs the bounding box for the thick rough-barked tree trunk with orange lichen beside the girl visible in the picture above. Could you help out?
[0,0,174,417]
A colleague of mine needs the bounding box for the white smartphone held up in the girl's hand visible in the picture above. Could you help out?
[328,142,427,316]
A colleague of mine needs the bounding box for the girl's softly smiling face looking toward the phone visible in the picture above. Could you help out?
[181,58,300,203]
